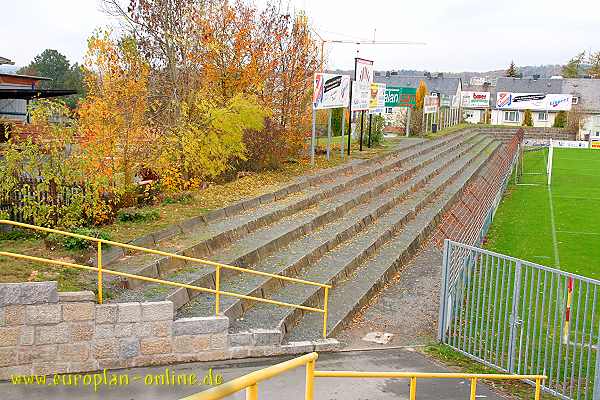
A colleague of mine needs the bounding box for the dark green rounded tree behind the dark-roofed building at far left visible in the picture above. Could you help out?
[17,49,84,108]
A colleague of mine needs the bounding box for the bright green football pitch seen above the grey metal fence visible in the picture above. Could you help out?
[484,148,600,279]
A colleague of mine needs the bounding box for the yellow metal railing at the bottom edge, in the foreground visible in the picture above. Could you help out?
[180,353,546,400]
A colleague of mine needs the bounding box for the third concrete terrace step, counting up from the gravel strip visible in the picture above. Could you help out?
[179,136,489,318]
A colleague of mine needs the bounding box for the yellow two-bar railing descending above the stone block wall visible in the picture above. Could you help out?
[0,220,331,337]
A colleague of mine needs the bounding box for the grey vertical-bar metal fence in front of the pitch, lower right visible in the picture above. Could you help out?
[438,240,600,399]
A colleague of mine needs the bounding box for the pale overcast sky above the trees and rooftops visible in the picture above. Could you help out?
[0,0,600,71]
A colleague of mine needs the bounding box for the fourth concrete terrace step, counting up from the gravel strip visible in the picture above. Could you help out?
[112,135,484,308]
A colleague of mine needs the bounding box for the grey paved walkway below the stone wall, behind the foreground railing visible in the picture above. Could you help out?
[0,349,501,400]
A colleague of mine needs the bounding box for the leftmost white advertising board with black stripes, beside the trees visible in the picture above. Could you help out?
[313,73,350,110]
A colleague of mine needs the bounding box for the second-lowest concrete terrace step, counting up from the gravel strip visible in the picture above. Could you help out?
[231,139,497,338]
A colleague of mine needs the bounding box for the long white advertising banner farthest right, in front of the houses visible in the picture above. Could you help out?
[496,92,573,111]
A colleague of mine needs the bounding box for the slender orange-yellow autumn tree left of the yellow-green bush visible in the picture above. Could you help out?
[79,31,155,200]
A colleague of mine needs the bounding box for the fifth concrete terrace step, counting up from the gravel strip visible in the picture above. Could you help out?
[106,131,469,288]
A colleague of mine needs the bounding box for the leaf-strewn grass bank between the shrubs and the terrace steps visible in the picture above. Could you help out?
[0,135,410,290]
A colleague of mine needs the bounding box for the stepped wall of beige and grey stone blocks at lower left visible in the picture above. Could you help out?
[0,282,338,380]
